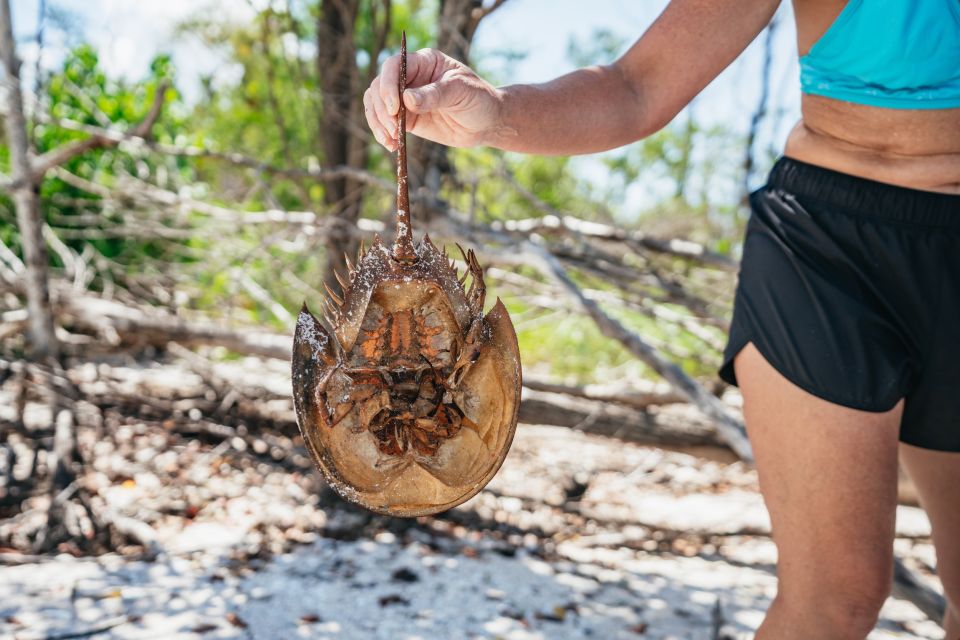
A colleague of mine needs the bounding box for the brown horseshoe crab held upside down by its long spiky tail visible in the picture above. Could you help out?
[292,36,521,516]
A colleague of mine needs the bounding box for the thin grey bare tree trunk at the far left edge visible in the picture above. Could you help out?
[0,0,58,361]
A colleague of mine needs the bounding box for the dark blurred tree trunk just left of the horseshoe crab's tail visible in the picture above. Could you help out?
[317,0,366,287]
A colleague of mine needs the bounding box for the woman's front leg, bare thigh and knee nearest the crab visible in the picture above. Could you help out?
[734,343,903,640]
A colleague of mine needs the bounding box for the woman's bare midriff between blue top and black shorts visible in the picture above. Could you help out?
[784,94,960,195]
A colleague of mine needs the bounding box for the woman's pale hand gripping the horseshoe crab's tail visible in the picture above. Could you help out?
[363,49,502,151]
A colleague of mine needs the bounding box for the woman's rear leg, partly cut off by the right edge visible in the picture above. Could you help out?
[900,444,960,640]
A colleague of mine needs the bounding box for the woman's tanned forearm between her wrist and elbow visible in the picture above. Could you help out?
[486,64,665,155]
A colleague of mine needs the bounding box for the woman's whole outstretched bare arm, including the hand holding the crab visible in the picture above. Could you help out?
[364,0,779,155]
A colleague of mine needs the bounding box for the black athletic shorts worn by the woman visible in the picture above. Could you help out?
[720,158,960,451]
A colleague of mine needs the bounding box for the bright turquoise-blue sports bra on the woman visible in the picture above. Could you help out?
[800,0,960,109]
